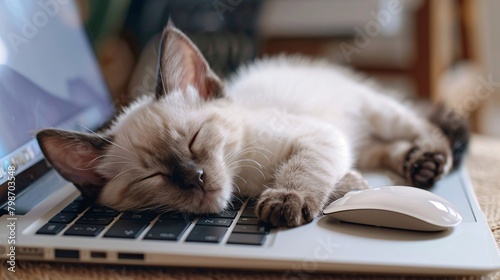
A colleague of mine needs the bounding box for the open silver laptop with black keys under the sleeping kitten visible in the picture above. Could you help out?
[0,0,500,278]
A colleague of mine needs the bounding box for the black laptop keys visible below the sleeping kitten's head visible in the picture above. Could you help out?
[36,197,271,246]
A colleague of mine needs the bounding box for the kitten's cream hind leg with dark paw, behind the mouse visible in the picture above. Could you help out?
[358,96,453,188]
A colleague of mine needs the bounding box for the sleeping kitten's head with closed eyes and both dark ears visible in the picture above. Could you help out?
[36,25,239,213]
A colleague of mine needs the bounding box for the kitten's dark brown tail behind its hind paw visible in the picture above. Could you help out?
[426,103,471,169]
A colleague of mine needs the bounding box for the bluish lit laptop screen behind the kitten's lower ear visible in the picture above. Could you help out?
[0,0,113,204]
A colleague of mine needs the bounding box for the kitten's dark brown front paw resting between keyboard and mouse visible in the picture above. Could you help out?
[255,189,321,227]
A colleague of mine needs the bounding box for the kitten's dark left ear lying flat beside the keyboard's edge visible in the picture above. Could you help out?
[36,129,110,200]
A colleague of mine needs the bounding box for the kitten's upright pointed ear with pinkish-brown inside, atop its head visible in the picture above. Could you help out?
[156,21,224,99]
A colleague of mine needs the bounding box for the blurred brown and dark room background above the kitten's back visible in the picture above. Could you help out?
[79,0,500,136]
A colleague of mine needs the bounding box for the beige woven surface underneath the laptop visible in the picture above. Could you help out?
[0,136,500,280]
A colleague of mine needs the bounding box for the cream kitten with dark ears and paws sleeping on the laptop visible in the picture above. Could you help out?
[36,25,466,227]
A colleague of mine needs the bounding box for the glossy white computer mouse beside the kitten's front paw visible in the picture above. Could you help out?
[323,186,462,231]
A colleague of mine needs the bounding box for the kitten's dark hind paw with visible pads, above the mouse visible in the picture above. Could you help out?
[403,147,446,188]
